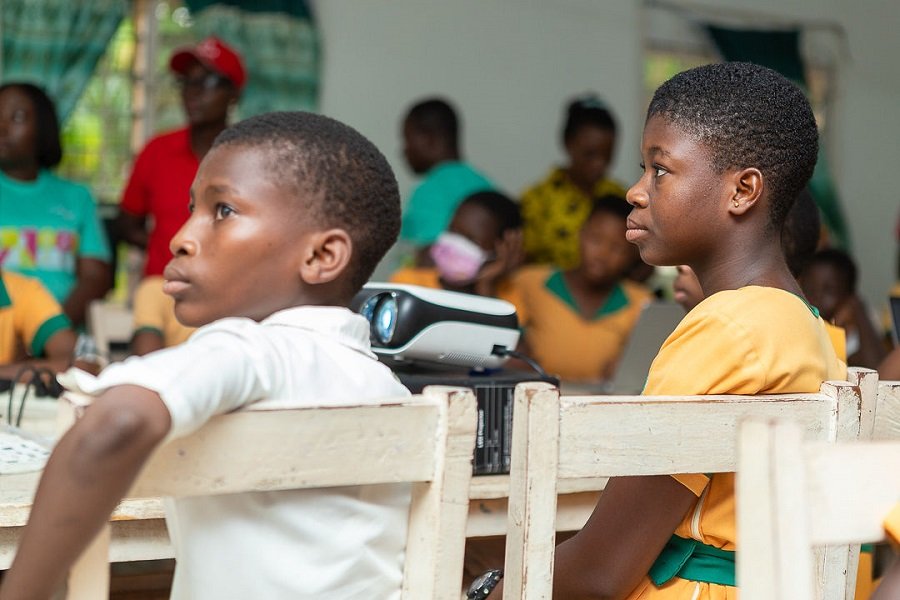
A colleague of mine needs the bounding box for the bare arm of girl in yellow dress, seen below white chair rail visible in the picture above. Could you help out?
[490,475,697,600]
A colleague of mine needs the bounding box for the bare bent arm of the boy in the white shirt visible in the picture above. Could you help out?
[0,385,171,600]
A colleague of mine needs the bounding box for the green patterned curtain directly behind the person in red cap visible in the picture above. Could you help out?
[186,0,320,117]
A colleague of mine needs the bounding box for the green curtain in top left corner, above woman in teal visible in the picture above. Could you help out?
[0,0,130,122]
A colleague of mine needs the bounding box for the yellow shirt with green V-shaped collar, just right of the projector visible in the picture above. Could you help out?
[513,266,652,381]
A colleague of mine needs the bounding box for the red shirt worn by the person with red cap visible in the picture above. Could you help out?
[120,128,200,275]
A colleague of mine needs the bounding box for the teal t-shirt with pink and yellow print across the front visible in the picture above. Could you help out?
[0,171,110,303]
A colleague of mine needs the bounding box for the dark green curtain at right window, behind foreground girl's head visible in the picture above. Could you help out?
[706,25,850,249]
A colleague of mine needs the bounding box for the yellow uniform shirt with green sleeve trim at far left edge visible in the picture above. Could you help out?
[0,271,72,364]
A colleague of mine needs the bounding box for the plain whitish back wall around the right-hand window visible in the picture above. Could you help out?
[314,0,900,304]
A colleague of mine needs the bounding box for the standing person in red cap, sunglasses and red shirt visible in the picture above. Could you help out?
[118,37,247,276]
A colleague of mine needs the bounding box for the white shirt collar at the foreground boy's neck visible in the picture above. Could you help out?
[262,306,376,358]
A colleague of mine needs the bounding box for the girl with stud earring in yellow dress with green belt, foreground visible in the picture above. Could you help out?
[482,63,846,600]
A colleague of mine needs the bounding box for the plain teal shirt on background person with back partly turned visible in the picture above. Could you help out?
[400,161,497,246]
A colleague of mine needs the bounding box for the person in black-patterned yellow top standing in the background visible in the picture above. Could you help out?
[522,95,625,269]
